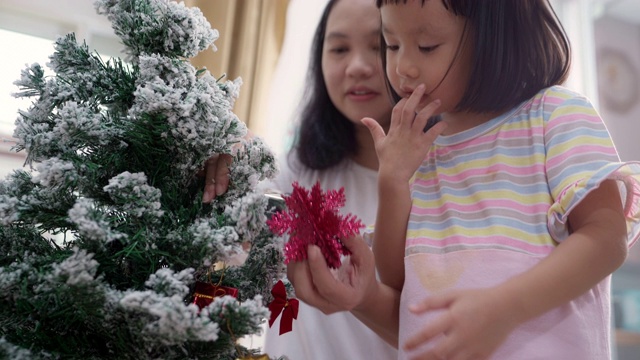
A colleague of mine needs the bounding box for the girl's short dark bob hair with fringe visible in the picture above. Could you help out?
[376,0,571,113]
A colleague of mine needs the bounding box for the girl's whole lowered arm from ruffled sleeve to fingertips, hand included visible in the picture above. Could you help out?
[408,180,627,359]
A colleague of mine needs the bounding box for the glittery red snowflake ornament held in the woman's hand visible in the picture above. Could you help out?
[267,182,364,269]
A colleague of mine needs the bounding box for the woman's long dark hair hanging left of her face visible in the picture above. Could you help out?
[291,0,358,170]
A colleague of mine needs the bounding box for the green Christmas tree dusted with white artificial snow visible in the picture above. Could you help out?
[0,0,284,359]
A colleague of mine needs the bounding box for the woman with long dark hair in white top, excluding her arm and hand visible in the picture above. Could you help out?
[265,0,397,360]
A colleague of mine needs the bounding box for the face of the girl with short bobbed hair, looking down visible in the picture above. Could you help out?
[380,0,471,113]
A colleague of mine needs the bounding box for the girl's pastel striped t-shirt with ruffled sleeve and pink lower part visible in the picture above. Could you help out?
[400,86,640,359]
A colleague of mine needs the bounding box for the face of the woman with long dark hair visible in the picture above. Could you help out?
[322,0,392,126]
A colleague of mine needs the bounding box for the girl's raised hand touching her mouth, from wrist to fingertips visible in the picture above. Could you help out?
[362,85,446,182]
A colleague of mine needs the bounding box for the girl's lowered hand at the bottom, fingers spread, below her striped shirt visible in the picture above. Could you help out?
[402,288,520,360]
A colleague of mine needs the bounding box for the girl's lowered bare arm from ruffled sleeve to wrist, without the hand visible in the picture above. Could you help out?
[501,180,628,321]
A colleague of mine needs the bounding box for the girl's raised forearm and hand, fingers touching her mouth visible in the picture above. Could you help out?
[362,85,446,291]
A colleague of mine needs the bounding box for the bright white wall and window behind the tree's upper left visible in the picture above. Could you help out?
[0,0,122,175]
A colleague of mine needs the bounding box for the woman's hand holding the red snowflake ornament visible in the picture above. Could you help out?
[287,236,377,314]
